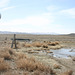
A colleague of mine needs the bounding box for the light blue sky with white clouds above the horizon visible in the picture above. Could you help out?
[0,0,75,34]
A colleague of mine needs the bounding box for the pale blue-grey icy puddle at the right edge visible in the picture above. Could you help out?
[49,48,75,58]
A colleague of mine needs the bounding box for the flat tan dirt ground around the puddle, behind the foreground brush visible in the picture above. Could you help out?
[0,34,75,75]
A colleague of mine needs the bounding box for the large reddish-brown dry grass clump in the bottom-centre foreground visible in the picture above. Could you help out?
[16,58,53,75]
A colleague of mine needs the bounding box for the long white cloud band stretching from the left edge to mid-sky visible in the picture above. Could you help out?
[0,16,53,26]
